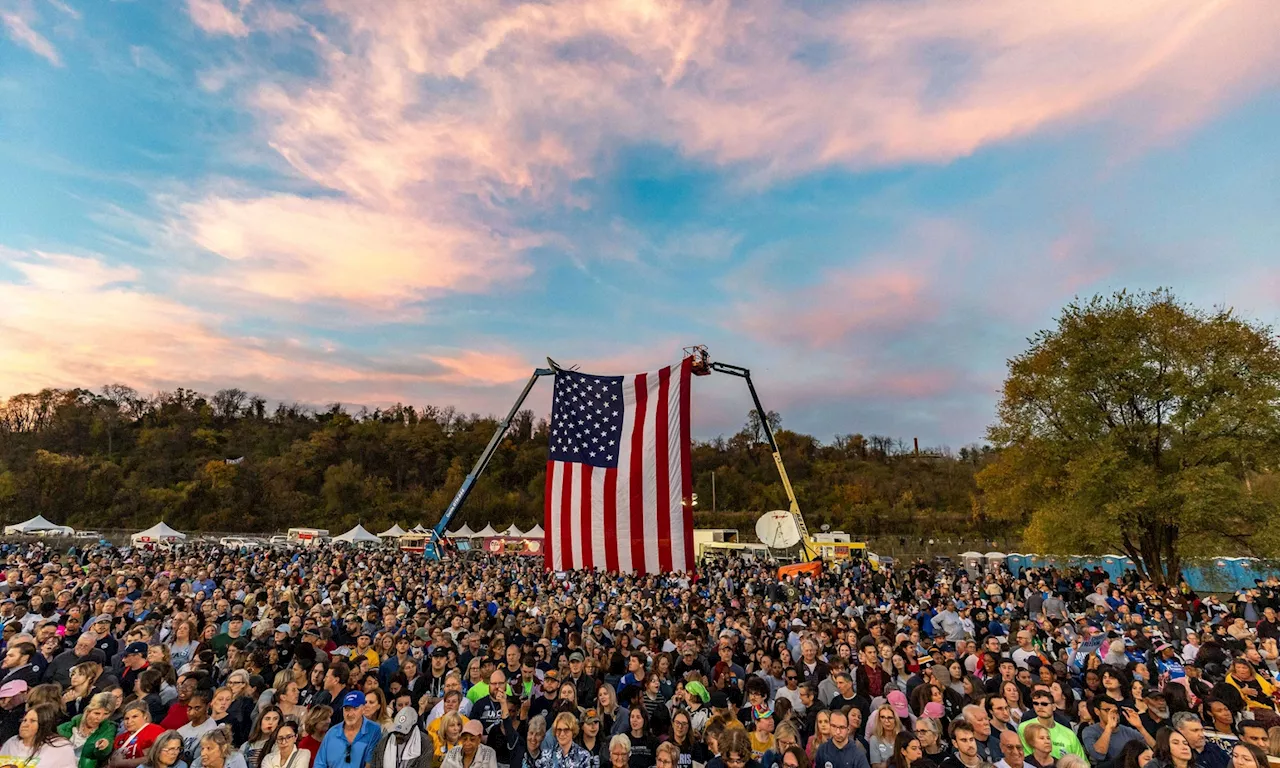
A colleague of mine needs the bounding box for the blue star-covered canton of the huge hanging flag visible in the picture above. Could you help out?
[550,371,623,468]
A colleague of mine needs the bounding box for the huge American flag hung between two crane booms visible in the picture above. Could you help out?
[544,358,694,573]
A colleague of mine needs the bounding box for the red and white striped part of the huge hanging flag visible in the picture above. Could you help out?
[543,358,694,573]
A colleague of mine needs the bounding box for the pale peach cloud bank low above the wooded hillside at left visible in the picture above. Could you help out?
[0,252,532,411]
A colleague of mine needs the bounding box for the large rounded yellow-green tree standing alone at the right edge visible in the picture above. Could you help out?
[978,291,1280,581]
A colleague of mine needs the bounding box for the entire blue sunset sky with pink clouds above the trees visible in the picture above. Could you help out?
[0,0,1280,447]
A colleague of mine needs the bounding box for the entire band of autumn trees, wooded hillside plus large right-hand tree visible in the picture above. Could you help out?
[0,291,1280,581]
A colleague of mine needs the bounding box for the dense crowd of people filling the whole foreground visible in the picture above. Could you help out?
[0,541,1280,768]
